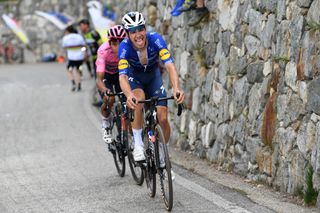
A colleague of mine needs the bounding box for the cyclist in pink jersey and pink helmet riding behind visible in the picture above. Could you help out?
[96,25,126,143]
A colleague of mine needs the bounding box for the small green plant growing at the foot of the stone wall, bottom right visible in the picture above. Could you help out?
[303,166,319,206]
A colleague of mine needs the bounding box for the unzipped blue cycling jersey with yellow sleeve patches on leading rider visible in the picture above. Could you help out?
[118,32,173,75]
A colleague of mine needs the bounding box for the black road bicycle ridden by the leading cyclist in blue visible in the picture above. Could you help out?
[138,94,182,211]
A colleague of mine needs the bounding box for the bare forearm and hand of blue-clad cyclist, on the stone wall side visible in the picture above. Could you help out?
[165,62,184,104]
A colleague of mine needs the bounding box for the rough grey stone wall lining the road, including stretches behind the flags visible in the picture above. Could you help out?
[3,0,320,203]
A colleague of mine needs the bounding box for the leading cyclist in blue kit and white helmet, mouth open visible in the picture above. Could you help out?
[118,12,184,161]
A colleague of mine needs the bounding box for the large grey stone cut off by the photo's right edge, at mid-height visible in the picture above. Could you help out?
[306,78,320,115]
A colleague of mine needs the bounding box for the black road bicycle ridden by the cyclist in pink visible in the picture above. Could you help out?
[105,92,144,185]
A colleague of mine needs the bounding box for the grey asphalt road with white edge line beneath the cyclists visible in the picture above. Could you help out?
[0,64,278,213]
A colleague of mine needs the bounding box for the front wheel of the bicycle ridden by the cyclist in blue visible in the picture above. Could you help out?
[155,124,173,211]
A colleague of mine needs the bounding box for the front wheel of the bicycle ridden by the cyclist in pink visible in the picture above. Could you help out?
[125,128,144,186]
